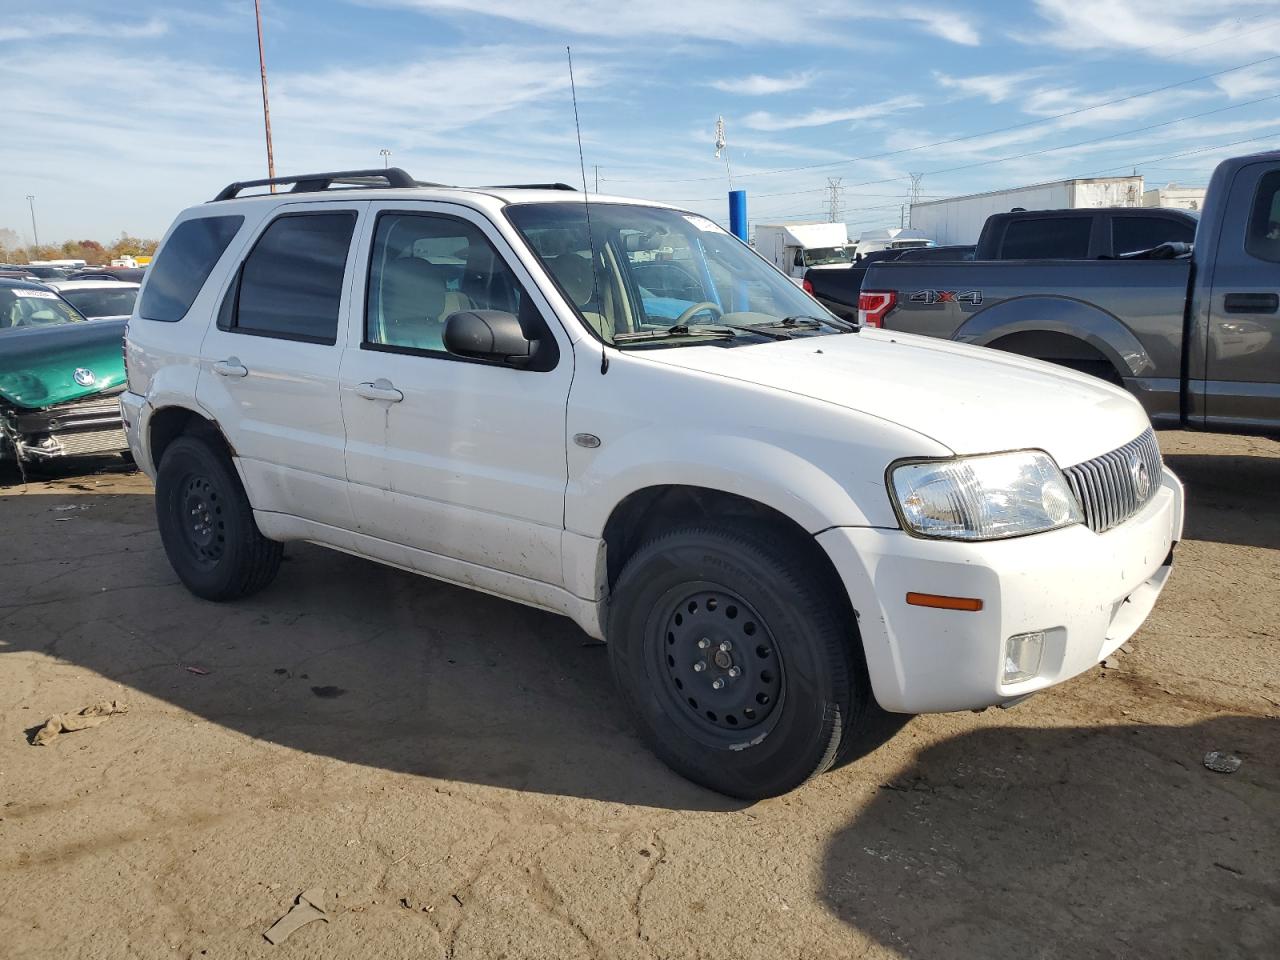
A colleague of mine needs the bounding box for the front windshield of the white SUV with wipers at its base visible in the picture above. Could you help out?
[507,202,849,347]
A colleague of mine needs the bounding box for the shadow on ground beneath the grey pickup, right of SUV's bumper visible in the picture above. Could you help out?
[1165,453,1280,549]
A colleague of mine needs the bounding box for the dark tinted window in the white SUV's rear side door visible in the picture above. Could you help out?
[233,211,356,343]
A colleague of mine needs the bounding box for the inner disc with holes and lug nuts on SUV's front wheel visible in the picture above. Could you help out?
[663,590,782,731]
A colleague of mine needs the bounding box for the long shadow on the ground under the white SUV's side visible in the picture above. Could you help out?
[0,476,741,810]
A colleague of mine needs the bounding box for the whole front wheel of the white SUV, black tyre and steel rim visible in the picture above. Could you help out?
[608,527,868,800]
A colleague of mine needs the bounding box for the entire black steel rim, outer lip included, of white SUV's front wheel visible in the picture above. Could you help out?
[646,584,783,742]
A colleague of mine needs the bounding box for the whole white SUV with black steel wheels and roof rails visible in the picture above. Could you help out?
[122,169,1183,797]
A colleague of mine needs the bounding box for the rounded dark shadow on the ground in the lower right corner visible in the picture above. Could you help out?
[823,717,1280,960]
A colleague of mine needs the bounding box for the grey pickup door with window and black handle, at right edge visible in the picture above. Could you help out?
[1204,163,1280,429]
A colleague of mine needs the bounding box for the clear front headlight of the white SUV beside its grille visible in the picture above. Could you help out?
[890,451,1084,540]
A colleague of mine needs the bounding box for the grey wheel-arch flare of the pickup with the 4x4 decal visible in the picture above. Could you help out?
[952,296,1156,376]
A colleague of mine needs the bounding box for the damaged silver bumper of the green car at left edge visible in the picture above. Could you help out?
[0,392,129,461]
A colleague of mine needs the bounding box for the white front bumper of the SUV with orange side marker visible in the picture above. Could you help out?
[818,467,1183,713]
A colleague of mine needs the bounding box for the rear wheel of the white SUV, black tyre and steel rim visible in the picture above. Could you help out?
[156,435,283,600]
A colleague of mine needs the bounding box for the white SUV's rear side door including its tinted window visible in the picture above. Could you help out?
[196,201,369,529]
